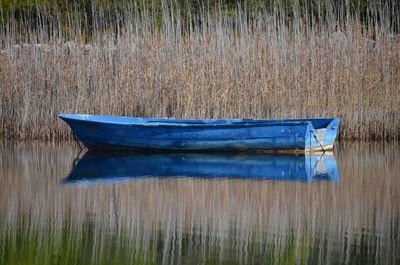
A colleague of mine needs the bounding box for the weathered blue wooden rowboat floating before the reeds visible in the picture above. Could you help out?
[58,114,339,151]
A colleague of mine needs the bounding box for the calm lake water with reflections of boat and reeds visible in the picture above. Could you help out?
[0,143,400,265]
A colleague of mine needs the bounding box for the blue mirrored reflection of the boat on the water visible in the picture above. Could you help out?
[64,152,339,183]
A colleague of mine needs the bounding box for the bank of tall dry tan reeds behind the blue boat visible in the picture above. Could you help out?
[0,2,400,139]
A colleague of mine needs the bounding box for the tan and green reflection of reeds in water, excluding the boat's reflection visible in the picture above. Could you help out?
[0,144,400,264]
